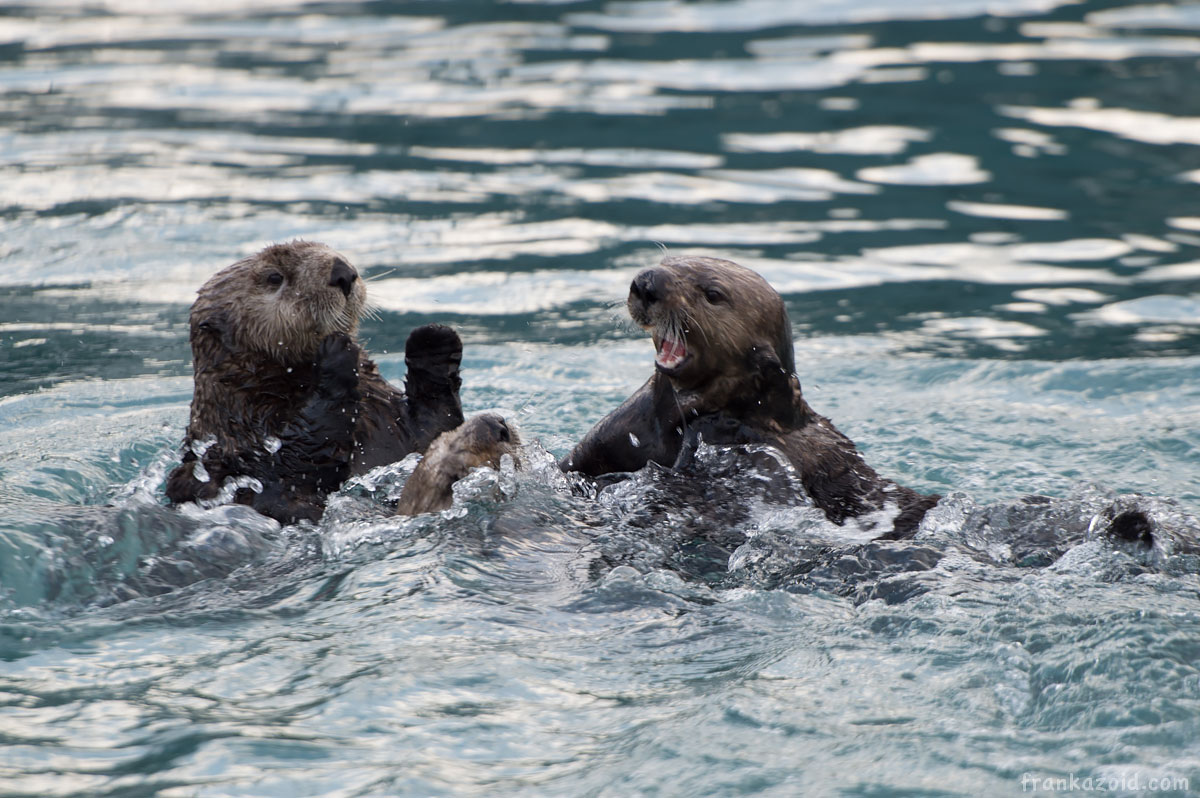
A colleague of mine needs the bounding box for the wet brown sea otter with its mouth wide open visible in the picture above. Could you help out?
[559,257,940,538]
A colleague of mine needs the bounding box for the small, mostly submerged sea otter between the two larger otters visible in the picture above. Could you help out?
[396,413,521,515]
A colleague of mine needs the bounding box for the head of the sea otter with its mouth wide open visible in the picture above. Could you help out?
[626,257,794,390]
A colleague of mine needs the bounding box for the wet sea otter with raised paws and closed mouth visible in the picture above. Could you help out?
[167,241,462,523]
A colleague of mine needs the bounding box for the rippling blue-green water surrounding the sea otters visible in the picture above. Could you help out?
[0,0,1200,798]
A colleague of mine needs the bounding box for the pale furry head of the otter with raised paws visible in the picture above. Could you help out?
[191,241,366,364]
